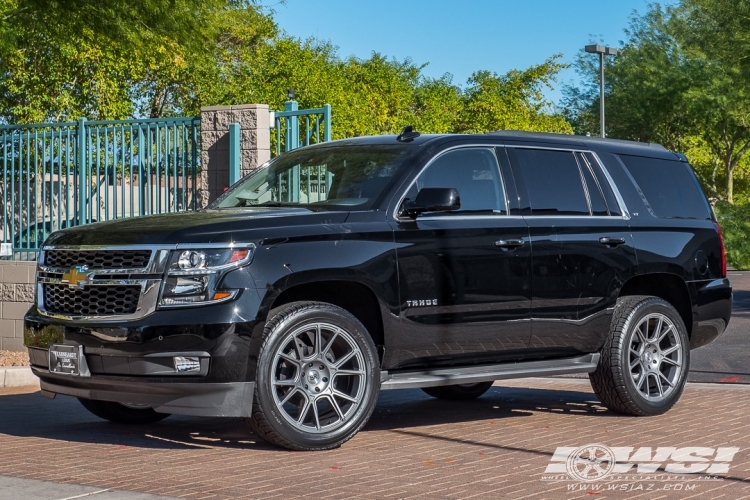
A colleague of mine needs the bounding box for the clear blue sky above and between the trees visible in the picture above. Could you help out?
[266,0,663,102]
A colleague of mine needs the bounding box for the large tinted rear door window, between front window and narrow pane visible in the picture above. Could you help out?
[508,149,591,215]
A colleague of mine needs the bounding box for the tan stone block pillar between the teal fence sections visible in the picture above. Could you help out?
[198,104,271,207]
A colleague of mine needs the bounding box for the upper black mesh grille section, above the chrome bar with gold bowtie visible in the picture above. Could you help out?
[44,250,151,269]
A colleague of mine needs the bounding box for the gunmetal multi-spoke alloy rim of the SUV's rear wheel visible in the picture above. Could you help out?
[629,313,683,402]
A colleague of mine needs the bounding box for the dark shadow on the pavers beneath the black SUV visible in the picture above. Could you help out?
[0,386,619,451]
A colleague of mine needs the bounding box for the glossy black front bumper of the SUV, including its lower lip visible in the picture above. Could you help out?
[24,289,264,417]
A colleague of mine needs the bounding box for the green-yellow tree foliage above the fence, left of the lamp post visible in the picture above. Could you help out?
[0,0,572,137]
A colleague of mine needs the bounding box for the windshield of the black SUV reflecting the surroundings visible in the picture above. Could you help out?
[212,144,413,210]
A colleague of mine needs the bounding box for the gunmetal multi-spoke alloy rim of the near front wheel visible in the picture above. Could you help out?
[273,322,365,434]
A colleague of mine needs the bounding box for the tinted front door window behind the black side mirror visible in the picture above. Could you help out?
[410,148,505,213]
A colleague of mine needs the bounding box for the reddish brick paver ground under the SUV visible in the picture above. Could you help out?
[0,379,750,500]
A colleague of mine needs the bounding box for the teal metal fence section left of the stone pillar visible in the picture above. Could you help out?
[0,118,201,260]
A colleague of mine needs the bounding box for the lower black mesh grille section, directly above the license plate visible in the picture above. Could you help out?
[42,283,141,316]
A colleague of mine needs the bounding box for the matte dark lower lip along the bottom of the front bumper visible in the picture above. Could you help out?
[31,366,255,417]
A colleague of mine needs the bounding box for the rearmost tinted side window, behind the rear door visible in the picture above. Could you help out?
[619,155,711,219]
